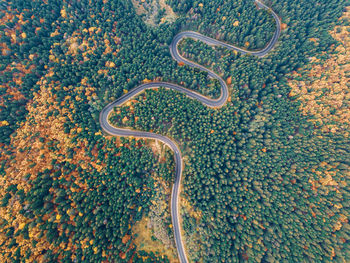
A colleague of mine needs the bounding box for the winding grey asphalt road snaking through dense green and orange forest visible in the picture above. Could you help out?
[100,0,281,263]
